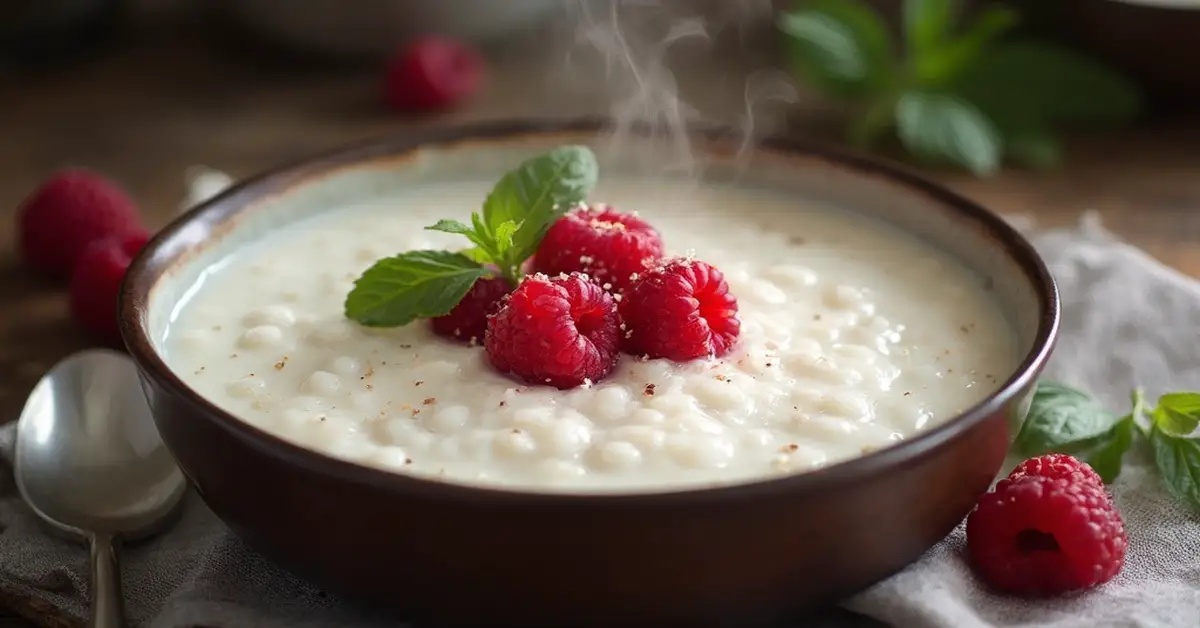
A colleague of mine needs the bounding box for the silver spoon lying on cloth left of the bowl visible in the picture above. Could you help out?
[13,349,186,628]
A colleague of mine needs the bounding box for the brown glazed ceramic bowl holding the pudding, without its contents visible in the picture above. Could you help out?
[121,122,1058,627]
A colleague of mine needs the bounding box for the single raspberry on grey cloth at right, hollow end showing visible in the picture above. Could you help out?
[967,476,1129,597]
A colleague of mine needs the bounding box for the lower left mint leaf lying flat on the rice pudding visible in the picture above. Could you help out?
[344,251,488,327]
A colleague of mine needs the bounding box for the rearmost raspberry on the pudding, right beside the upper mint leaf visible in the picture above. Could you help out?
[533,205,662,292]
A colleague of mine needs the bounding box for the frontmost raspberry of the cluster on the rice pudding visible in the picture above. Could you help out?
[485,273,620,389]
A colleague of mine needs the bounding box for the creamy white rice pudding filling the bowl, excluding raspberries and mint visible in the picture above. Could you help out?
[164,179,1018,491]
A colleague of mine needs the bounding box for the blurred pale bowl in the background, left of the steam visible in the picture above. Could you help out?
[223,0,575,56]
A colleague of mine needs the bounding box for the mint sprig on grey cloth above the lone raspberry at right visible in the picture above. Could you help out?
[1013,381,1200,510]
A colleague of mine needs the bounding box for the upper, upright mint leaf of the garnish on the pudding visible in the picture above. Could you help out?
[482,145,600,274]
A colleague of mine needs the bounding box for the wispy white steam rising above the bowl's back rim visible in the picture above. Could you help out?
[568,0,797,180]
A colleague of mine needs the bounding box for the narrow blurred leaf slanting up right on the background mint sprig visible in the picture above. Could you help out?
[905,2,1019,88]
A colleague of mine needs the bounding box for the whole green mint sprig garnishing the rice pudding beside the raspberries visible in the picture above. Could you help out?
[344,145,599,327]
